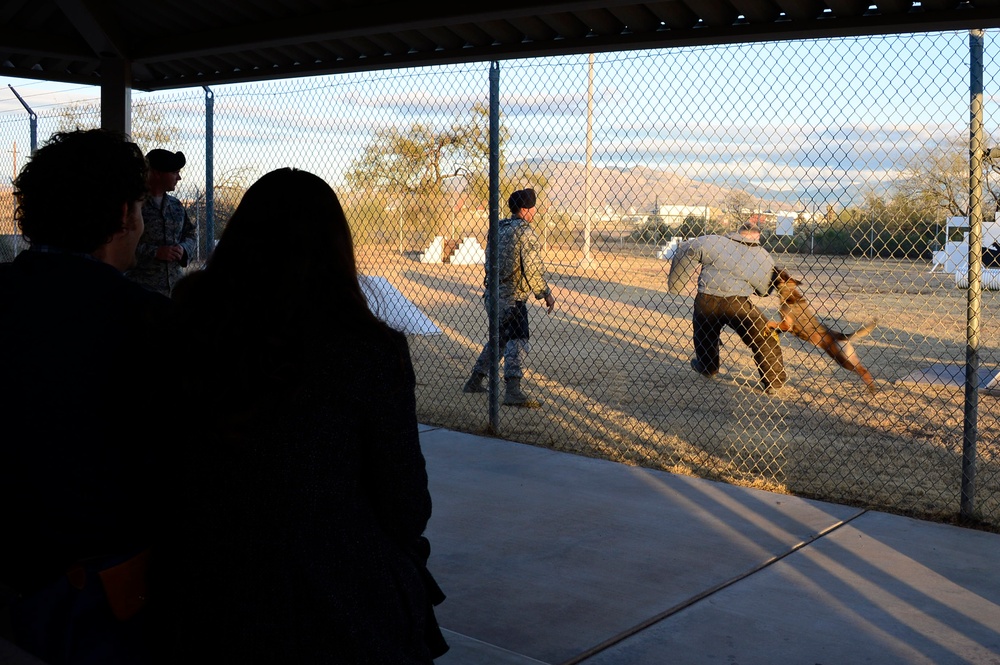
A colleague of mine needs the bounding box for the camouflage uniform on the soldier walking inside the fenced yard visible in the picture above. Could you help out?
[472,217,550,380]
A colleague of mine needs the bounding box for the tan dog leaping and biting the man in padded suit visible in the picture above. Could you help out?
[767,268,878,393]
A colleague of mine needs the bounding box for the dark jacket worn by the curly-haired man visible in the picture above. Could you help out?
[0,250,169,591]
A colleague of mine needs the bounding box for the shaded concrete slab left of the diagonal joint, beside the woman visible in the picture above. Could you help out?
[421,428,862,663]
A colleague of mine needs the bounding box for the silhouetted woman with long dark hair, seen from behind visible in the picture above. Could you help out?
[154,169,447,665]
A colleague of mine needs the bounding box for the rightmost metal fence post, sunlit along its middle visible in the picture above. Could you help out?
[960,30,984,518]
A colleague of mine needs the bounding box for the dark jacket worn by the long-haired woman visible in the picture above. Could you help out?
[153,330,443,665]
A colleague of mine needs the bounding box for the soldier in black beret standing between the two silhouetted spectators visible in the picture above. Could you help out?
[129,148,198,296]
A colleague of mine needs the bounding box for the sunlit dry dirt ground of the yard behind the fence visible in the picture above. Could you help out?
[358,245,1000,528]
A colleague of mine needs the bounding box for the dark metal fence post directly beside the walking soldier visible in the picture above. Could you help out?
[486,60,500,434]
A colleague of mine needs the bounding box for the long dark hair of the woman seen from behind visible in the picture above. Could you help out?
[173,168,389,413]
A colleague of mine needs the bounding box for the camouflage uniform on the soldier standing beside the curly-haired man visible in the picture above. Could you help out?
[128,194,198,296]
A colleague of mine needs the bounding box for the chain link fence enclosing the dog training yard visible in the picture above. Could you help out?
[0,32,1000,528]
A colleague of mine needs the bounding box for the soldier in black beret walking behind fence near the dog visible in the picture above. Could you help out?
[462,189,556,406]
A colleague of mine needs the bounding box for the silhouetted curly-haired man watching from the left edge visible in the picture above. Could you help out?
[0,130,169,665]
